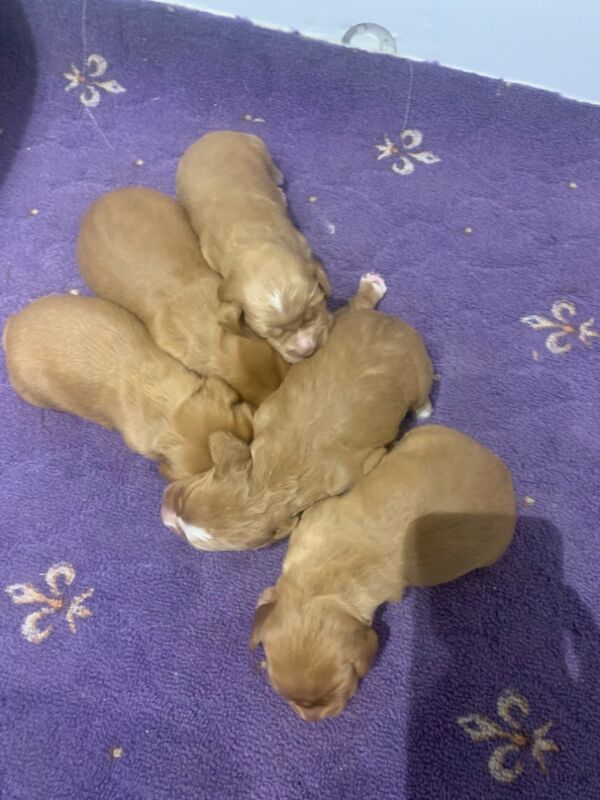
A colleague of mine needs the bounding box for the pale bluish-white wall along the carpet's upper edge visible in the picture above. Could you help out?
[152,0,600,103]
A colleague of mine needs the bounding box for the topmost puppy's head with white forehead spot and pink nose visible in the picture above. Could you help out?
[219,245,332,364]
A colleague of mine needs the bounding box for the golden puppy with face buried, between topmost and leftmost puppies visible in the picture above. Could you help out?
[77,187,287,406]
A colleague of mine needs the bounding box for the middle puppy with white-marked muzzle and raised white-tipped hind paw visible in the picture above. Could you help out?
[162,279,432,550]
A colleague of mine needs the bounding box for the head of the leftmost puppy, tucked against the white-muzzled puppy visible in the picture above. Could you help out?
[157,378,253,481]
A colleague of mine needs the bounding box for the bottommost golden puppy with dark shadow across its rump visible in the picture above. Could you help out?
[250,425,516,720]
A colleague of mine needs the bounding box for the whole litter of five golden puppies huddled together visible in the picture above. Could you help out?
[2,131,516,721]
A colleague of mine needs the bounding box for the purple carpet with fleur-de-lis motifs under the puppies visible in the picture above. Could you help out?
[0,0,600,800]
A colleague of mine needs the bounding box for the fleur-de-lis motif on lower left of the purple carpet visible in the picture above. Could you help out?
[5,563,94,644]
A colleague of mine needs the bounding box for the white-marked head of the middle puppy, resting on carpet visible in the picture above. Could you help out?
[161,431,272,550]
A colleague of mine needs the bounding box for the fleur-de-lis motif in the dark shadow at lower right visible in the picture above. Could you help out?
[457,689,560,783]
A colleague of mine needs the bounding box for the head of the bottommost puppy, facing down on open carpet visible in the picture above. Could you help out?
[250,582,378,722]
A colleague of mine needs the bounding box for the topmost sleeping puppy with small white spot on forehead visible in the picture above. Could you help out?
[177,131,331,364]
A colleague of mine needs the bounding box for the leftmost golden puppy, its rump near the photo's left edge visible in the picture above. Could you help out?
[2,295,252,480]
